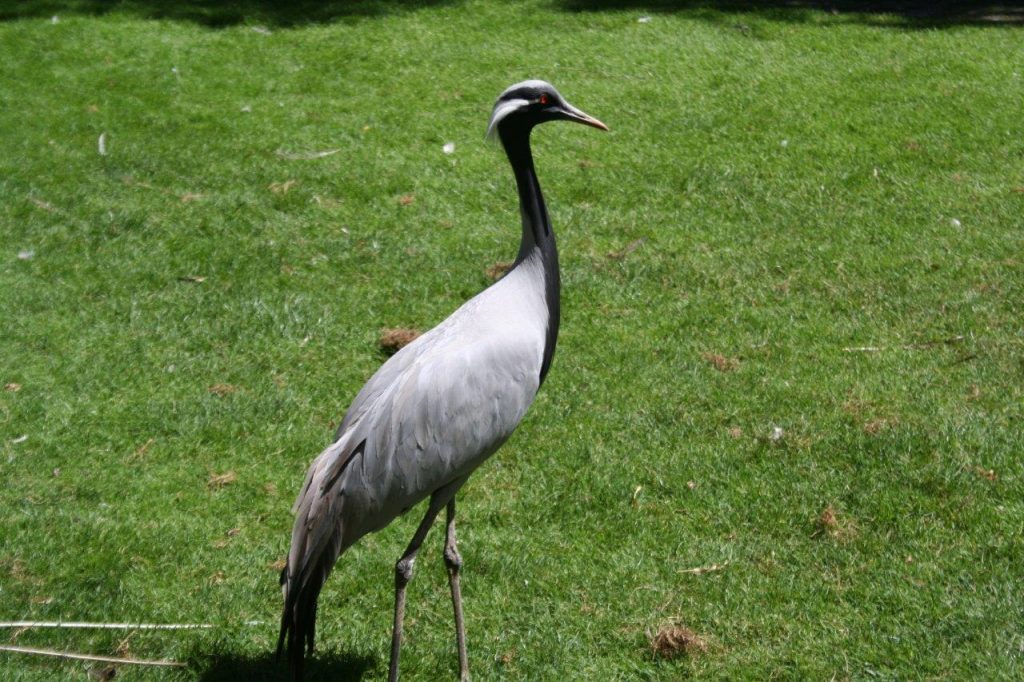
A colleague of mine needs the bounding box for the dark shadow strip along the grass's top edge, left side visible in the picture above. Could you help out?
[0,0,457,28]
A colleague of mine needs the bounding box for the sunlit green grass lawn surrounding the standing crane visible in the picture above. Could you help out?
[0,0,1024,680]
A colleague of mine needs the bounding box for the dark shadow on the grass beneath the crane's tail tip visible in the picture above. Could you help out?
[191,651,375,682]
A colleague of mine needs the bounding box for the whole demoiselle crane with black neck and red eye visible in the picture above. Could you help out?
[278,80,607,681]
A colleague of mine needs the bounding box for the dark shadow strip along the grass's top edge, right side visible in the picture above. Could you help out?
[554,0,1024,28]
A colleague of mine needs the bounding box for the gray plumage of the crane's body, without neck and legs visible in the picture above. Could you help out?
[289,249,548,579]
